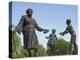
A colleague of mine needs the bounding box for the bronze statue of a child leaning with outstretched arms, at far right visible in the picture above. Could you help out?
[60,19,77,54]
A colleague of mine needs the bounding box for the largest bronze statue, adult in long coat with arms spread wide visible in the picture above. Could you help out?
[15,8,49,56]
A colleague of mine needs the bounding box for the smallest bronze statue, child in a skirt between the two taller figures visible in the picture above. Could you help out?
[46,29,57,56]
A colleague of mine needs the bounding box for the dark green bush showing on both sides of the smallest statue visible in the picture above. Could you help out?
[47,38,69,55]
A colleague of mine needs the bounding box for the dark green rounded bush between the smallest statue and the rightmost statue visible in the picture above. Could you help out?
[56,38,69,55]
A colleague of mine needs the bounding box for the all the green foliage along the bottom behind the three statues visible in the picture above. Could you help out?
[12,27,77,58]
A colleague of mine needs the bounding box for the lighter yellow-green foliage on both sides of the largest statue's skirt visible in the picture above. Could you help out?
[12,31,46,58]
